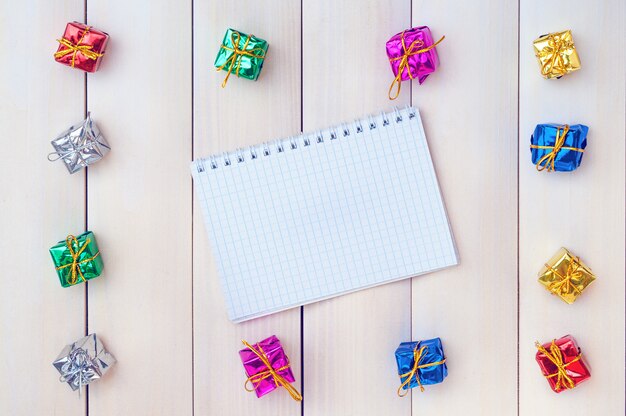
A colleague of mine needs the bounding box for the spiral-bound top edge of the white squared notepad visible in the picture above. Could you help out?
[196,105,417,173]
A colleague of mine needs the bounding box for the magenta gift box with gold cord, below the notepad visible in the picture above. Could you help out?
[239,335,302,401]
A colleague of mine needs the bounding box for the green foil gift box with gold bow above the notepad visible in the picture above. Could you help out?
[215,29,269,88]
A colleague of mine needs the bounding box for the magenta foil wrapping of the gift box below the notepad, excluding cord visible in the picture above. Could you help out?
[239,335,296,397]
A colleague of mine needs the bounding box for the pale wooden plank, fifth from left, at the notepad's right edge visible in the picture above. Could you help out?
[413,0,517,415]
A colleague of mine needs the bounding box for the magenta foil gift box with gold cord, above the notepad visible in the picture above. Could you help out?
[386,26,445,100]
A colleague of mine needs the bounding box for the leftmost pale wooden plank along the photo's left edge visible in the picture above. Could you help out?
[0,0,85,416]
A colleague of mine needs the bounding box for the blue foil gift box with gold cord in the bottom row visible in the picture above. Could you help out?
[396,338,448,397]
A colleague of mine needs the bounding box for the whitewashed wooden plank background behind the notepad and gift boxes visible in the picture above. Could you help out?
[0,0,626,416]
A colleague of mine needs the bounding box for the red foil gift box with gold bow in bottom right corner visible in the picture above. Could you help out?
[535,335,591,393]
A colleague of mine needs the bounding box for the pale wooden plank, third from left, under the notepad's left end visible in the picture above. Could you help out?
[193,0,301,416]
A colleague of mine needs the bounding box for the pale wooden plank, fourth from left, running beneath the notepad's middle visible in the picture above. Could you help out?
[303,0,411,416]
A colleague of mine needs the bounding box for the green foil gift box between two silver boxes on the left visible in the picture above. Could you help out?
[50,231,104,287]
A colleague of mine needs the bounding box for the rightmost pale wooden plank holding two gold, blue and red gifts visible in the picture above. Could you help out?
[519,0,626,416]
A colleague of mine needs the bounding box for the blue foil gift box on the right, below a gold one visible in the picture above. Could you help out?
[530,124,589,172]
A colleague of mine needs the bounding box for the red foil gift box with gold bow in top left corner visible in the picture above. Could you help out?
[54,22,109,72]
